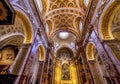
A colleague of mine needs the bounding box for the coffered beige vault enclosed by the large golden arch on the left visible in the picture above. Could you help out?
[0,18,25,47]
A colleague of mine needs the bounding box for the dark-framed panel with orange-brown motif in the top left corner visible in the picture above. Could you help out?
[0,0,15,25]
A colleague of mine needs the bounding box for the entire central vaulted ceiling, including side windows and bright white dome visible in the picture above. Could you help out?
[35,0,89,60]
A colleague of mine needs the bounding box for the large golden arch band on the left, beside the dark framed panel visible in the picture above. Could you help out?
[16,10,33,43]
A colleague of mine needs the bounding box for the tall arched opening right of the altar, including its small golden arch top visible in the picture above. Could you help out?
[86,42,106,84]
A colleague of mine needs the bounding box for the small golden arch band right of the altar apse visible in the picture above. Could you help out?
[86,42,96,60]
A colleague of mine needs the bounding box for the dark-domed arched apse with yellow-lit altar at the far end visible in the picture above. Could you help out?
[55,47,78,84]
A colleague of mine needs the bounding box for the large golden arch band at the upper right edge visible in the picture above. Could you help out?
[99,0,120,40]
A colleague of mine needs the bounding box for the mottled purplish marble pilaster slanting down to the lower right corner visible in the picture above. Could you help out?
[91,31,120,84]
